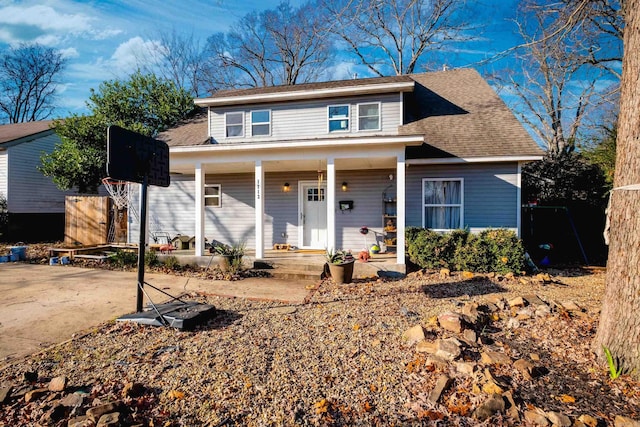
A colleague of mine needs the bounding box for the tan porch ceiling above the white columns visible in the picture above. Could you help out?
[169,157,396,175]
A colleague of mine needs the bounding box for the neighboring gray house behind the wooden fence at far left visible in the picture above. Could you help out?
[0,120,75,242]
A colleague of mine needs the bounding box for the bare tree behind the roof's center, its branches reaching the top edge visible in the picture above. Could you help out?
[322,0,471,76]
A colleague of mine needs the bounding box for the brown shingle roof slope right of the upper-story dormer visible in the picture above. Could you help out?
[399,69,543,158]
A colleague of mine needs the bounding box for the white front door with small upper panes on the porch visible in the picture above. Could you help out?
[298,181,327,249]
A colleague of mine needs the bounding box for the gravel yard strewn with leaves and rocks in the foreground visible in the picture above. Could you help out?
[0,270,640,426]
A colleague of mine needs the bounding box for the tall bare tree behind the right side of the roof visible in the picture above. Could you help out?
[498,0,622,156]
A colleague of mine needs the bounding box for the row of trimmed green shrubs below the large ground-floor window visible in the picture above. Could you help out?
[406,227,525,274]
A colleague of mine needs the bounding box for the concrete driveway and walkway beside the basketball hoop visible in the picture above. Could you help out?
[0,263,313,365]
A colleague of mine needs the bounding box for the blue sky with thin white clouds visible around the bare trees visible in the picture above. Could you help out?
[0,0,519,115]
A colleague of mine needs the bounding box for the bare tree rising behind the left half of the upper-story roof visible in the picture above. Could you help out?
[201,1,332,90]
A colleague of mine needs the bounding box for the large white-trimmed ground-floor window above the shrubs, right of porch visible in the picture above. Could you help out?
[422,178,464,230]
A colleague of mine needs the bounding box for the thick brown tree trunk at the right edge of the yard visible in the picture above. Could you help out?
[594,0,640,376]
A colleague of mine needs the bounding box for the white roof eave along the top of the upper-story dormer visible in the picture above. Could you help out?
[194,81,415,107]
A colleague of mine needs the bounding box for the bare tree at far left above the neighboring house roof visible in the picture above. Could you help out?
[0,44,67,123]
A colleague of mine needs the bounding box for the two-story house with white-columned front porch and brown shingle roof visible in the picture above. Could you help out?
[144,69,543,264]
